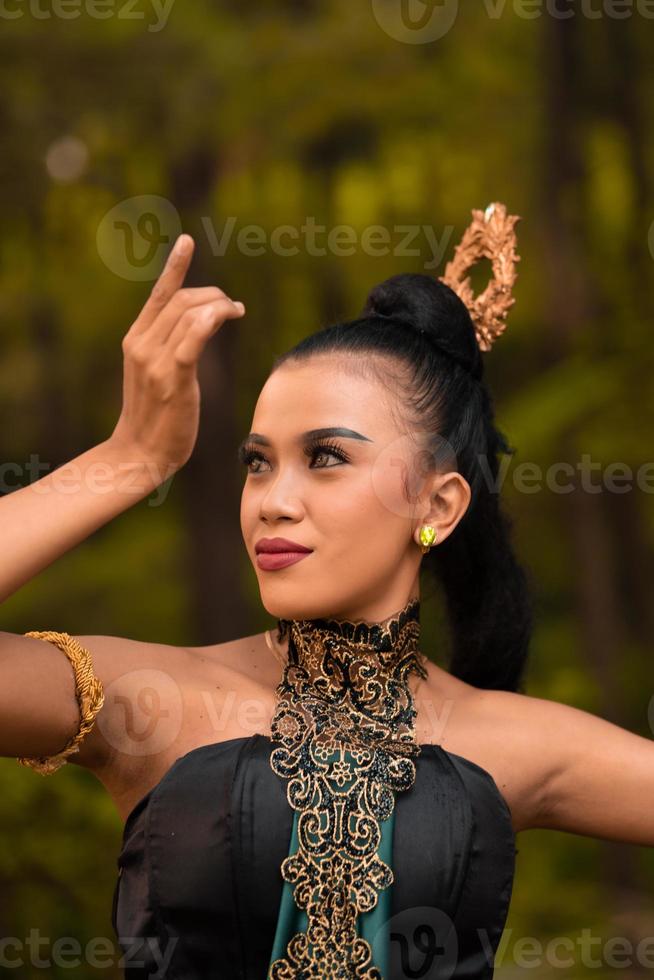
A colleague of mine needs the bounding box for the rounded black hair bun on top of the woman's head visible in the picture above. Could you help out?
[361,272,484,380]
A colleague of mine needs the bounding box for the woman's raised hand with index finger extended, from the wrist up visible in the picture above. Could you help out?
[109,234,245,482]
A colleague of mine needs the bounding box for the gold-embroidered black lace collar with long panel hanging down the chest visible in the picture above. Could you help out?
[269,599,427,980]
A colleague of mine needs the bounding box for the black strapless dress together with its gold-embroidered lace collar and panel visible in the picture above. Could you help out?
[112,599,516,980]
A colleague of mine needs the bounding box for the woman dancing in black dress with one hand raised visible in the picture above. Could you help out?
[0,211,654,980]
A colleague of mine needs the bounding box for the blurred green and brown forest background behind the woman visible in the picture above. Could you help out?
[0,0,654,980]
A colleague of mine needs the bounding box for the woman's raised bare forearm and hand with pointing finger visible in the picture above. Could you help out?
[0,235,243,602]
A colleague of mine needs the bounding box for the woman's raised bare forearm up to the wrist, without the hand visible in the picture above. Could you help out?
[0,440,172,602]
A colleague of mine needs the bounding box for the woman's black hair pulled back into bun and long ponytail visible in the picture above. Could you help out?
[272,273,533,691]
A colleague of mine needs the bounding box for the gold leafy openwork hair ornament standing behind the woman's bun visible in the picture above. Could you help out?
[439,201,520,351]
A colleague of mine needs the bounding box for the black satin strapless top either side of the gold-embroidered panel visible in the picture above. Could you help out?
[111,734,517,980]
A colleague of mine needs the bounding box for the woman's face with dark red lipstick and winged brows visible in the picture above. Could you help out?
[241,355,465,622]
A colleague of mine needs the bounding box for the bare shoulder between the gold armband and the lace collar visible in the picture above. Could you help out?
[57,634,275,818]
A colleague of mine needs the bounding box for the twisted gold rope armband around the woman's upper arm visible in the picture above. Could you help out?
[16,630,104,776]
